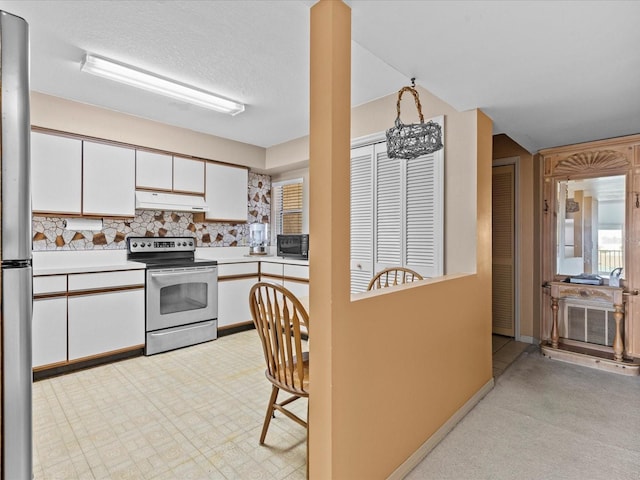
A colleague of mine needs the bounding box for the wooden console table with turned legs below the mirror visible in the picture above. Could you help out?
[549,282,624,362]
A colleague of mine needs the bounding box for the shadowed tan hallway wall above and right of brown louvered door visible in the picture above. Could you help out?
[493,134,541,340]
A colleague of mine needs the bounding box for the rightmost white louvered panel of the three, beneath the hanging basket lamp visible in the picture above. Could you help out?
[404,151,444,277]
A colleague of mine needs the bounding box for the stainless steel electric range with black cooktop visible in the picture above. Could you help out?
[127,237,218,355]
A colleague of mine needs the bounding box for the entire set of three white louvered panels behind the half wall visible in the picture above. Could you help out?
[351,118,444,293]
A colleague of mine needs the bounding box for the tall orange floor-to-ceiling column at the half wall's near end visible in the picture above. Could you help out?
[307,0,351,479]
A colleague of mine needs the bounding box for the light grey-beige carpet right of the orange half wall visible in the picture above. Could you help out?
[406,347,640,480]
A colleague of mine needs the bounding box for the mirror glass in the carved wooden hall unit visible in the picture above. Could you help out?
[556,175,626,278]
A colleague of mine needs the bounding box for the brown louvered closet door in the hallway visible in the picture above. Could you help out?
[491,165,515,337]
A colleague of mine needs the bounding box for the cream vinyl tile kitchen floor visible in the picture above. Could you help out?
[33,331,307,480]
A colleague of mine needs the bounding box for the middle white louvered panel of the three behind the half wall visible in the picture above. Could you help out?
[374,143,403,272]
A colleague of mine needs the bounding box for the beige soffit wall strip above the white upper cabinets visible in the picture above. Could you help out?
[31,92,265,171]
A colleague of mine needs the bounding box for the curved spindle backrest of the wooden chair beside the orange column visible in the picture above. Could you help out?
[249,282,309,396]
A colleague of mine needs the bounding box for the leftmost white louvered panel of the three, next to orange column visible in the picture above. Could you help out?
[351,145,373,293]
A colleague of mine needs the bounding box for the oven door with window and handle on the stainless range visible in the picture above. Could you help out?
[147,266,218,332]
